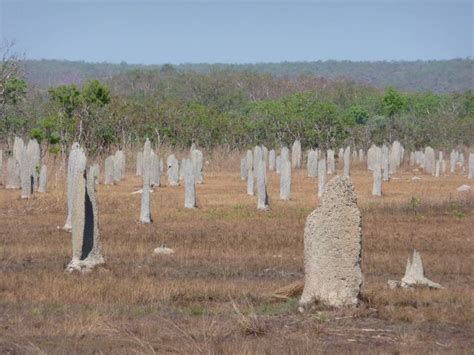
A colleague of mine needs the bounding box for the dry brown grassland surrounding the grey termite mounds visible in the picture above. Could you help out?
[0,154,474,354]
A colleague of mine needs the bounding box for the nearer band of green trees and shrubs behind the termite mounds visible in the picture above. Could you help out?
[0,48,474,154]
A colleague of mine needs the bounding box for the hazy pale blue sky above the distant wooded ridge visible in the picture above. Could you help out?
[0,0,474,64]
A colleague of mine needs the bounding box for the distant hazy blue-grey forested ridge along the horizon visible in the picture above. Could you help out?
[22,58,474,93]
